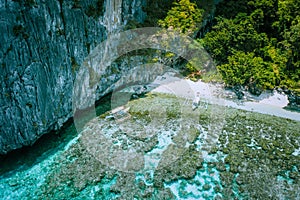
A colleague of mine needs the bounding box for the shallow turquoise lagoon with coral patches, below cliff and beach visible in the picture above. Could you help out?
[0,93,300,199]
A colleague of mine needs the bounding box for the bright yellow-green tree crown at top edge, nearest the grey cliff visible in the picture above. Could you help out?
[158,0,204,35]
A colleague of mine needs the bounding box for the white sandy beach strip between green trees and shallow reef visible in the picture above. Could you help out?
[152,74,300,121]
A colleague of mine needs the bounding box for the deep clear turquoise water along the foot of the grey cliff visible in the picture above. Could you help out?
[0,95,112,200]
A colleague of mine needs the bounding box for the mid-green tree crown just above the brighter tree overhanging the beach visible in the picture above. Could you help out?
[201,16,269,64]
